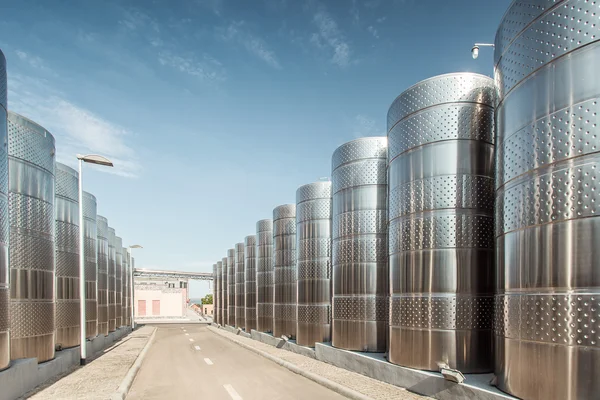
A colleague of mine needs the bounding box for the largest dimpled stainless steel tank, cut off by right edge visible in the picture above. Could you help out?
[494,0,600,400]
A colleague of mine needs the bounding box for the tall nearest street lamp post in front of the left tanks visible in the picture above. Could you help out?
[77,154,113,365]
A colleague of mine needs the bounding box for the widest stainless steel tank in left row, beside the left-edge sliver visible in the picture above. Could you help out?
[8,111,56,362]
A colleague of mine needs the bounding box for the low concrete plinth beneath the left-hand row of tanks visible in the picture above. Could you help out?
[0,327,131,400]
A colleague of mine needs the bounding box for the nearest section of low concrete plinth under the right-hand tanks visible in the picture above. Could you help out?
[315,343,515,400]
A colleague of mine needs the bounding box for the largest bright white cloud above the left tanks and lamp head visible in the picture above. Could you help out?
[8,74,141,177]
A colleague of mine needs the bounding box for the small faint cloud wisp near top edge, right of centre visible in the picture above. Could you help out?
[311,10,352,67]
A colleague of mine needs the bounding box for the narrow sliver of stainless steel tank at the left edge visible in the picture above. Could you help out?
[0,51,10,370]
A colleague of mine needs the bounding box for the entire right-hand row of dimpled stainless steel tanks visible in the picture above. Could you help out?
[214,0,600,399]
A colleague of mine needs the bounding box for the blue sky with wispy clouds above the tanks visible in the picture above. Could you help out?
[0,0,510,296]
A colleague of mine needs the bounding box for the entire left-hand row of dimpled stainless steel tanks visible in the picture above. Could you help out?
[0,52,133,370]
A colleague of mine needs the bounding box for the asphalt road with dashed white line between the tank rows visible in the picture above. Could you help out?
[127,324,344,400]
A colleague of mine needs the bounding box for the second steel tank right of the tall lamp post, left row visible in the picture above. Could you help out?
[96,215,108,336]
